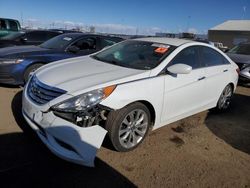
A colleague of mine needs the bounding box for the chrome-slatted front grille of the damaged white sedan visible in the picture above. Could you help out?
[27,76,66,105]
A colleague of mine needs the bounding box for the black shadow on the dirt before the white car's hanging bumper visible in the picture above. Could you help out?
[0,92,135,187]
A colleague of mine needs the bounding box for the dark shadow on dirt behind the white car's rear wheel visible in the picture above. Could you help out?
[205,94,250,154]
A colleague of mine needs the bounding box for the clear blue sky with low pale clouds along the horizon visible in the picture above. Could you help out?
[0,0,250,35]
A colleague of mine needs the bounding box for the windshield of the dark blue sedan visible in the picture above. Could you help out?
[40,35,76,49]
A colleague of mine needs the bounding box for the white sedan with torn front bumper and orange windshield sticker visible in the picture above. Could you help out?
[23,38,238,166]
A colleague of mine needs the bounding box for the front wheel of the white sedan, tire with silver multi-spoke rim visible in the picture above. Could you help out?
[106,102,151,152]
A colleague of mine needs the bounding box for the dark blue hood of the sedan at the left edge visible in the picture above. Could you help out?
[0,45,49,58]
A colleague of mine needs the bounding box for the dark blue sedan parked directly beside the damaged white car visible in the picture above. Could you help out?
[0,33,123,85]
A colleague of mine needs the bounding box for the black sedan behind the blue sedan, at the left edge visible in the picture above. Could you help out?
[0,30,63,48]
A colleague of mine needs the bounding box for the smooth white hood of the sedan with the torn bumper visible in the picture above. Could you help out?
[36,56,150,95]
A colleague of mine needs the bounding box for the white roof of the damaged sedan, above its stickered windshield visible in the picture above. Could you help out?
[133,37,193,46]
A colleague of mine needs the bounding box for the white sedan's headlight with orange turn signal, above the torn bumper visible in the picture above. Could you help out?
[52,86,116,112]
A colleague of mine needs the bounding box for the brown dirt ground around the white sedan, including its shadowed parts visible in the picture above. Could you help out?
[0,86,250,188]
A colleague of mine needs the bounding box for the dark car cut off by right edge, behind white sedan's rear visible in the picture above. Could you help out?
[227,42,250,82]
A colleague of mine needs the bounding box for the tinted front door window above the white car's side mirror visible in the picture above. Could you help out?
[168,46,200,69]
